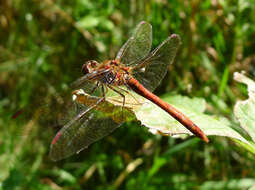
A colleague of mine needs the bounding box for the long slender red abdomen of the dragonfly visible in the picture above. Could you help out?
[127,78,209,142]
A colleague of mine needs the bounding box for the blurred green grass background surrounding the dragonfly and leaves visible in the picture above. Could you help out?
[0,0,255,190]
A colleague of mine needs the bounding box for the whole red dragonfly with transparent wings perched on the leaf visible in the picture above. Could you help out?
[50,21,209,160]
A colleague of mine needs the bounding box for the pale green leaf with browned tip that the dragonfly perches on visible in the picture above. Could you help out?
[75,87,252,148]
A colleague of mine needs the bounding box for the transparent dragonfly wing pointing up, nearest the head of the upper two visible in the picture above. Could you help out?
[115,21,152,66]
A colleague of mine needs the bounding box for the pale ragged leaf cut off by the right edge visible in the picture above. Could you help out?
[234,73,255,141]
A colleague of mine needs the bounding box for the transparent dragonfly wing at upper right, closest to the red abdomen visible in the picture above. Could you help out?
[133,34,181,91]
